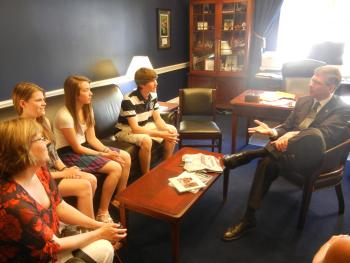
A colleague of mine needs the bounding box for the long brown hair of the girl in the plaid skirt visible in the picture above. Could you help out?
[64,76,95,131]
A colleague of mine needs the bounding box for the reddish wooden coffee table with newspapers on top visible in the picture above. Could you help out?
[118,148,224,262]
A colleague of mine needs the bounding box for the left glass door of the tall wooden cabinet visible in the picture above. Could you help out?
[191,4,215,71]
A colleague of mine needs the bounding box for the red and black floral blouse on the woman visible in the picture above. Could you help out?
[0,168,62,262]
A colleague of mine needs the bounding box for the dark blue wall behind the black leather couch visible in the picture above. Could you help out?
[0,0,188,101]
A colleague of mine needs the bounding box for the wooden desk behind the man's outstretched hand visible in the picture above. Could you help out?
[230,90,294,153]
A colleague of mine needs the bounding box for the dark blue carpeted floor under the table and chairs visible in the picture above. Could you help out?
[115,115,350,263]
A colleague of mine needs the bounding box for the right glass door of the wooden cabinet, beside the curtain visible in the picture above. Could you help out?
[219,1,247,72]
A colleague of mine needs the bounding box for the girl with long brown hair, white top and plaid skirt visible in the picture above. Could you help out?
[54,76,131,222]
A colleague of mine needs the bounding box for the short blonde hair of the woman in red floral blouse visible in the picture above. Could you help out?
[0,119,43,177]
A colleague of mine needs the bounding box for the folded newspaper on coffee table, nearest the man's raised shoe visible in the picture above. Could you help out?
[182,153,223,173]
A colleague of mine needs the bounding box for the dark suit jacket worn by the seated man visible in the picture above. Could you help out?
[276,95,350,149]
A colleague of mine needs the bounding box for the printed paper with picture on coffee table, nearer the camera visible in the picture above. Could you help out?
[169,171,206,193]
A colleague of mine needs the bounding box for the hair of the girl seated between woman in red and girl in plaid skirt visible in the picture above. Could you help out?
[12,81,55,142]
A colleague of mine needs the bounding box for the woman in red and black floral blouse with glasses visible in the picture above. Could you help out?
[0,119,126,262]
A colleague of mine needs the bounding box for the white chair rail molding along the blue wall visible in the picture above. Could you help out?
[0,62,189,109]
